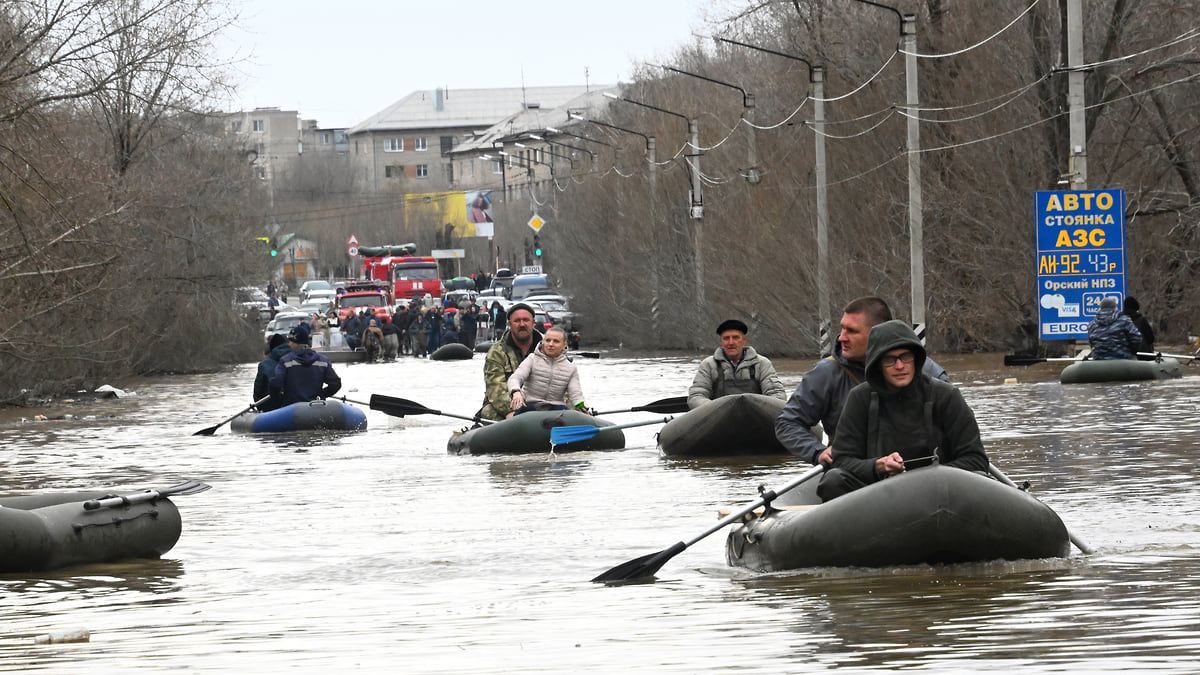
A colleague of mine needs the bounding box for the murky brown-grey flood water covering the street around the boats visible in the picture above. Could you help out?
[0,354,1200,674]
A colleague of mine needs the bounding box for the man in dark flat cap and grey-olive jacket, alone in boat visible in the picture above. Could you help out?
[688,318,787,410]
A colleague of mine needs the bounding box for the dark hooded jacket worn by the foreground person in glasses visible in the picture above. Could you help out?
[833,321,988,483]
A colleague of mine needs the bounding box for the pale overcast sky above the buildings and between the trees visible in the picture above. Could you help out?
[216,0,714,127]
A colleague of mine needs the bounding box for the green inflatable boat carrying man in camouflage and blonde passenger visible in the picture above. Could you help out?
[446,410,625,455]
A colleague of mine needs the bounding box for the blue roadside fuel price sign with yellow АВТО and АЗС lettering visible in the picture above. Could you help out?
[1036,190,1126,340]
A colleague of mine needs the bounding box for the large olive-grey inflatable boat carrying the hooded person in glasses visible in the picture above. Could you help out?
[725,466,1070,572]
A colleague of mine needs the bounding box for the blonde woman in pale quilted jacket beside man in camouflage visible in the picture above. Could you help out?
[509,325,587,414]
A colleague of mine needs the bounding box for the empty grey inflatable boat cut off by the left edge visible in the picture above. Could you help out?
[0,480,201,572]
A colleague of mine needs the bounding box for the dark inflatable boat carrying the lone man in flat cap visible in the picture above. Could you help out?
[659,394,787,458]
